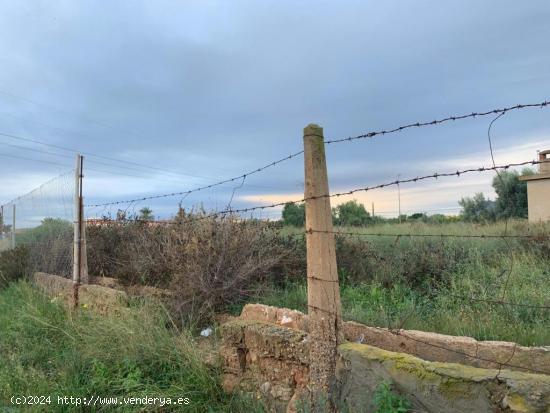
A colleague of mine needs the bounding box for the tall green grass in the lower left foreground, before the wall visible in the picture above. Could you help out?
[0,282,261,413]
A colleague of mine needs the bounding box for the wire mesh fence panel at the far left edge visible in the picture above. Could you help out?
[0,170,75,277]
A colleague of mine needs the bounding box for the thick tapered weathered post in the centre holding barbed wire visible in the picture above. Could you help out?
[304,124,343,411]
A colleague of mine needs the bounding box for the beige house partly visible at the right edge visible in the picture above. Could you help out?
[519,150,550,222]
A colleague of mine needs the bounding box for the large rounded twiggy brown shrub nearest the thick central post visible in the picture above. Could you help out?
[170,218,282,317]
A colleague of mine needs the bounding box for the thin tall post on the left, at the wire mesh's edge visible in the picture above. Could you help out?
[73,154,88,305]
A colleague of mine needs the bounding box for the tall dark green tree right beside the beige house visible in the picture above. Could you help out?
[493,168,534,218]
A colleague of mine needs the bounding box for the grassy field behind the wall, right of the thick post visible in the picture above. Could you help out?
[254,221,550,346]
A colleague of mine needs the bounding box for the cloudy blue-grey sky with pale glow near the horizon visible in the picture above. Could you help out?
[0,0,550,222]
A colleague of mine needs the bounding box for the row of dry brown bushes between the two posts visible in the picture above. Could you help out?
[88,214,285,321]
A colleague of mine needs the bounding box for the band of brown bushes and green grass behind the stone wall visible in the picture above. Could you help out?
[5,211,550,345]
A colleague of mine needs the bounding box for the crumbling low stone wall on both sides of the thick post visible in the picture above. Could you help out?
[221,305,550,413]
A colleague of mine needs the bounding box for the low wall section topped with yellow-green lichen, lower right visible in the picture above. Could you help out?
[337,343,550,413]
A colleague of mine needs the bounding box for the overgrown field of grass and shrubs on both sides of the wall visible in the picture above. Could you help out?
[0,220,550,412]
